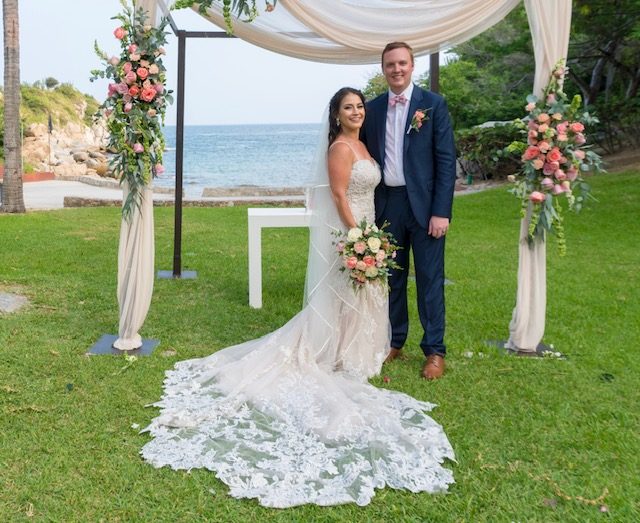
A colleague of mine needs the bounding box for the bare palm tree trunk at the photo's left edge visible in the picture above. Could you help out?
[1,0,25,212]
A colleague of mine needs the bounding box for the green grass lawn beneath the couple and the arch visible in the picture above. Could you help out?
[0,172,640,522]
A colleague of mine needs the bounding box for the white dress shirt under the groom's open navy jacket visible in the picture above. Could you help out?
[384,83,413,187]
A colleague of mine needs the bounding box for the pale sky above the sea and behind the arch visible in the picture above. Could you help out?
[0,0,436,125]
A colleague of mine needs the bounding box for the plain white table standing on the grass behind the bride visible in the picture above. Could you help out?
[248,207,311,309]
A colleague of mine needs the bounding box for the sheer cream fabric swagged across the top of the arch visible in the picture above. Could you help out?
[184,0,520,64]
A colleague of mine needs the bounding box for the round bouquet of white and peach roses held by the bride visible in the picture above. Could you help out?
[334,219,399,290]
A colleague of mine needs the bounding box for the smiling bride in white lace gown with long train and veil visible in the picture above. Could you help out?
[141,87,454,508]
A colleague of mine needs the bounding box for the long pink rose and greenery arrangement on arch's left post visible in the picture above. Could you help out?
[91,0,173,218]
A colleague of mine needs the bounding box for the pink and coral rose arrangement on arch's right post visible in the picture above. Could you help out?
[507,60,602,255]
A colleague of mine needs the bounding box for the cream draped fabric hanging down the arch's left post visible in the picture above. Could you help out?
[113,0,156,351]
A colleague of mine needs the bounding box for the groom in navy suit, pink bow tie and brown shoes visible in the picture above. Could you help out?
[362,42,456,380]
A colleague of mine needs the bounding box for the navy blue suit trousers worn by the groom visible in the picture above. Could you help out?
[378,187,446,356]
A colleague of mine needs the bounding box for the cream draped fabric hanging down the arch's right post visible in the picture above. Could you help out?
[507,0,571,352]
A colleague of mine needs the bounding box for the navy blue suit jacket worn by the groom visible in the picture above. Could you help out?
[361,85,456,229]
